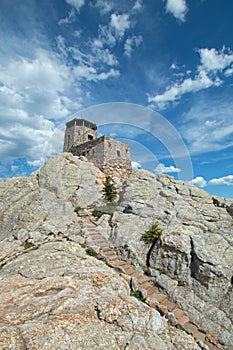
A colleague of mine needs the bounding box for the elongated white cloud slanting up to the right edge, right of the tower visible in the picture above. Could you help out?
[148,47,233,109]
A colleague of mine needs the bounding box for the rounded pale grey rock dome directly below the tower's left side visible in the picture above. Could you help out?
[0,153,102,240]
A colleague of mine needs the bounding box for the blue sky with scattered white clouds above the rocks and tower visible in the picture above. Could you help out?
[0,0,233,197]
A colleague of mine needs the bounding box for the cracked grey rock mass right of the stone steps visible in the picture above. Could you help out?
[108,170,233,346]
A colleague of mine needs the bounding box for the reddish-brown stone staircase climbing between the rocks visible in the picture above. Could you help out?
[82,215,226,350]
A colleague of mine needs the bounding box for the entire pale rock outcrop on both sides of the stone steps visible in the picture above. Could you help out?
[0,153,233,350]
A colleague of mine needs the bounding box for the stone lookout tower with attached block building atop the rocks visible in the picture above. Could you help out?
[63,118,132,181]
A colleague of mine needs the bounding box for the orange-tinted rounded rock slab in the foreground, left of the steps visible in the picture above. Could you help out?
[0,241,171,350]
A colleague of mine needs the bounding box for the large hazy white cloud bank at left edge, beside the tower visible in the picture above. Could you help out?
[0,49,78,166]
